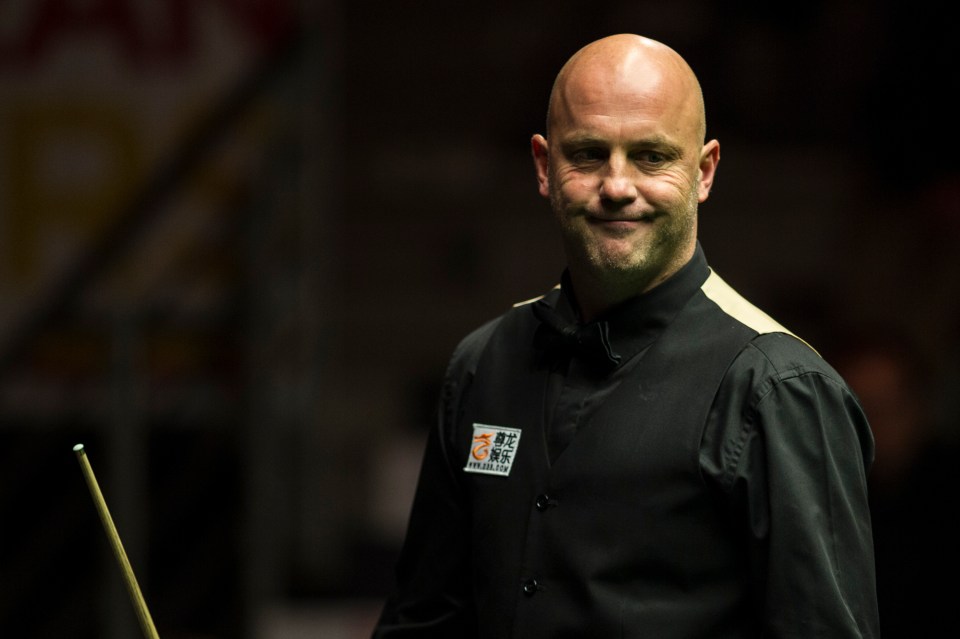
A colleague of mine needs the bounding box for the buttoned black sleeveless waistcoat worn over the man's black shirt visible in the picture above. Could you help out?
[451,289,756,639]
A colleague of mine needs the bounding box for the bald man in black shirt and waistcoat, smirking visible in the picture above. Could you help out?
[374,34,877,639]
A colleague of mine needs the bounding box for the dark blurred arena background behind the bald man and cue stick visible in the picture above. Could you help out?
[0,0,960,639]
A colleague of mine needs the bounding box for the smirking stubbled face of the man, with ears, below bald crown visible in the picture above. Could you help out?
[533,57,719,290]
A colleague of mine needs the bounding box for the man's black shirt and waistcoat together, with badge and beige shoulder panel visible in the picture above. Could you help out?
[375,246,877,639]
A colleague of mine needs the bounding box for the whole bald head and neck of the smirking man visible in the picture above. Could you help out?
[530,34,720,320]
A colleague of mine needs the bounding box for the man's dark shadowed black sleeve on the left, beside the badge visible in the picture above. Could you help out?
[373,323,495,639]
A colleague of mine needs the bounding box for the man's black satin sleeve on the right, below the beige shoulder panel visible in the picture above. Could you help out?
[702,336,879,639]
